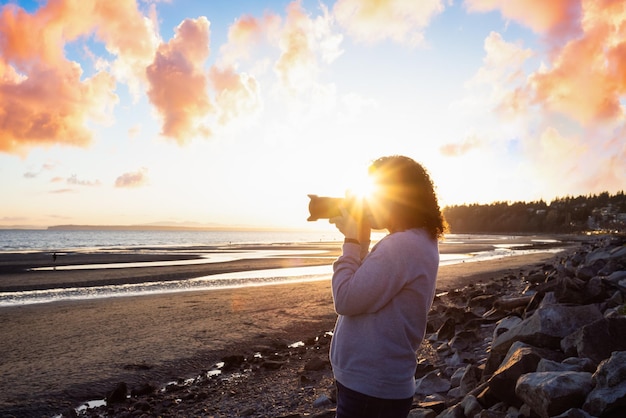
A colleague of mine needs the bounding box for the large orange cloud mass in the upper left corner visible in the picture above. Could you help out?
[0,0,163,154]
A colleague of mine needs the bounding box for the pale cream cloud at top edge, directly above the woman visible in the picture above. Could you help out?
[333,0,444,46]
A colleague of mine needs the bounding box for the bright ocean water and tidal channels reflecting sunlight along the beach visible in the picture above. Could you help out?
[0,230,559,307]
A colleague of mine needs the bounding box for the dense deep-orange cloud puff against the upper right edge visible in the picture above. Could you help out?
[530,1,626,126]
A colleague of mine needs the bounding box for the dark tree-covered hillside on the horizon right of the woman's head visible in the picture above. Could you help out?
[443,191,626,234]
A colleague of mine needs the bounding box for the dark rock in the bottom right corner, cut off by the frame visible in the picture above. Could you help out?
[583,351,626,416]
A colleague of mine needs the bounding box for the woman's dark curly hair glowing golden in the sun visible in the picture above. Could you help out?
[369,155,447,239]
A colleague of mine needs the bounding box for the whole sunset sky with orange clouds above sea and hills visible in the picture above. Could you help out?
[0,0,626,228]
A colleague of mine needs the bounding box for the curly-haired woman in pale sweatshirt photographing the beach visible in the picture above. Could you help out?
[330,156,445,418]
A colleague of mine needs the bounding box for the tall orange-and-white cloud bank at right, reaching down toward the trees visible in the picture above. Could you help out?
[456,0,626,198]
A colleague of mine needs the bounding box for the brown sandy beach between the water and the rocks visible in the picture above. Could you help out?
[0,238,572,416]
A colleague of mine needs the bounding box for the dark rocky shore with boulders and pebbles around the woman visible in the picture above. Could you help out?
[22,236,626,418]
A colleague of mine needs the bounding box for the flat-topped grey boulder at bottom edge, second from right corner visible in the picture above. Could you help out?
[515,372,593,418]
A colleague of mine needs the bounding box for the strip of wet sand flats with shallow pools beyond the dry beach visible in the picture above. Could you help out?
[0,237,572,294]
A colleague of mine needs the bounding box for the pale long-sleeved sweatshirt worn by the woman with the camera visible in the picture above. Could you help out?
[330,229,439,399]
